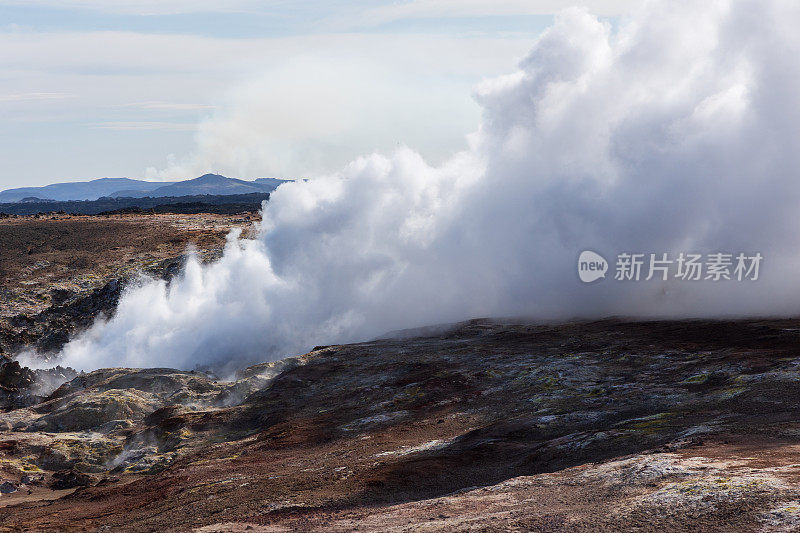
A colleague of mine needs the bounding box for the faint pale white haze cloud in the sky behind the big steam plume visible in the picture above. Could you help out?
[148,42,520,178]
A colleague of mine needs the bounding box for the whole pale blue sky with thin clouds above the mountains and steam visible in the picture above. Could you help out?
[0,0,637,189]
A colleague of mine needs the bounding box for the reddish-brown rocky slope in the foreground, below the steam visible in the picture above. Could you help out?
[0,314,800,531]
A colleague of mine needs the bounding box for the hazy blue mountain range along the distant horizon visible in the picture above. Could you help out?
[0,174,291,203]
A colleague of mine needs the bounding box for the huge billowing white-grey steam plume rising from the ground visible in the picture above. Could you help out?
[31,0,800,369]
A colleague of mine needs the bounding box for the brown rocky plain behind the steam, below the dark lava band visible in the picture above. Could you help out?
[0,214,257,355]
